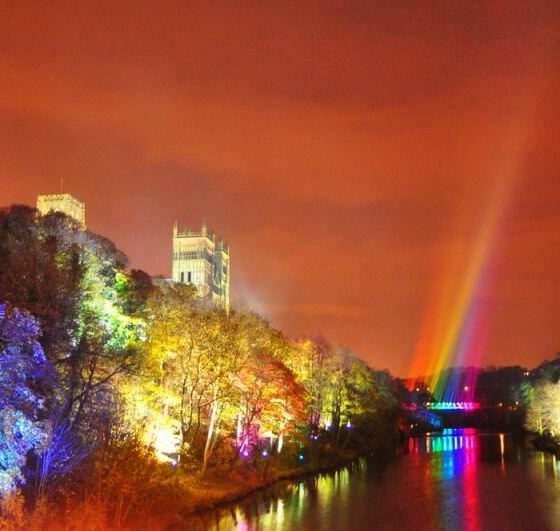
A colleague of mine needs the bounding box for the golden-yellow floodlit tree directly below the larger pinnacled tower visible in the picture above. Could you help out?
[128,284,252,470]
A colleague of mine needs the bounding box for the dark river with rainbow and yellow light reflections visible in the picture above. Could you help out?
[188,429,560,531]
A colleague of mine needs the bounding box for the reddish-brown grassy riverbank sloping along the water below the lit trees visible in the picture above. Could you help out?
[7,451,368,531]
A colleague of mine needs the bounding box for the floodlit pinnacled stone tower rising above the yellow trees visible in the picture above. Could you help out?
[172,223,230,310]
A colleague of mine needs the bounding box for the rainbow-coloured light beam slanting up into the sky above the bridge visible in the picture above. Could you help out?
[411,102,529,402]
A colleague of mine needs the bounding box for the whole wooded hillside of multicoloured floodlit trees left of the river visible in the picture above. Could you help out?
[0,206,397,529]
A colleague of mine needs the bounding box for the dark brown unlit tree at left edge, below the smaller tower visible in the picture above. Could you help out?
[0,206,84,364]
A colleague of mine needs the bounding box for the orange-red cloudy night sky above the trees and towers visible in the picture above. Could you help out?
[0,0,560,376]
